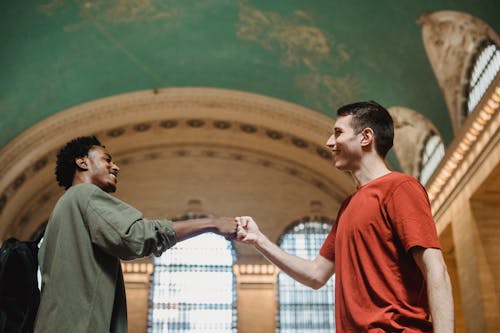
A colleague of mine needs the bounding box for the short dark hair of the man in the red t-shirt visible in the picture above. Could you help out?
[337,101,394,158]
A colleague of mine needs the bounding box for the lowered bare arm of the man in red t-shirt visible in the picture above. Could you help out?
[410,246,454,333]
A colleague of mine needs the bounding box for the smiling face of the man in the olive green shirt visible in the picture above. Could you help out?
[87,146,120,193]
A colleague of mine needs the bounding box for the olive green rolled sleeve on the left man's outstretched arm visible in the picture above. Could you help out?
[84,188,177,259]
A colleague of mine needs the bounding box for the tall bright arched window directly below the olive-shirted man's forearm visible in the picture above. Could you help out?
[148,215,237,333]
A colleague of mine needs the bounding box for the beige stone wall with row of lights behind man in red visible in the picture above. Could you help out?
[429,75,500,332]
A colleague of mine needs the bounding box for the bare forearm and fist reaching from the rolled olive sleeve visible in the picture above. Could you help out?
[172,217,238,242]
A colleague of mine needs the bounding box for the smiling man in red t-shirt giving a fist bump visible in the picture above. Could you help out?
[237,101,453,333]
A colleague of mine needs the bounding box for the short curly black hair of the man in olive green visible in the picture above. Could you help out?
[55,136,103,190]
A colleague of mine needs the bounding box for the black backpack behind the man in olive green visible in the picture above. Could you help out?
[0,238,40,333]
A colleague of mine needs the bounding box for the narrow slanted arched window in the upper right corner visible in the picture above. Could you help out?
[467,41,500,112]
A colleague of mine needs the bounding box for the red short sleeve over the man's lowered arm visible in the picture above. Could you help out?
[387,180,440,252]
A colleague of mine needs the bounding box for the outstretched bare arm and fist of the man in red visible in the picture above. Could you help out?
[236,216,334,289]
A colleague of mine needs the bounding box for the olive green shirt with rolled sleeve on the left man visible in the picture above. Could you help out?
[35,184,177,333]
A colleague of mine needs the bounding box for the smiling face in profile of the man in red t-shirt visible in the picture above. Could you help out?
[326,115,363,172]
